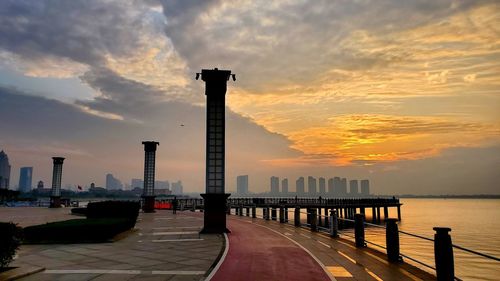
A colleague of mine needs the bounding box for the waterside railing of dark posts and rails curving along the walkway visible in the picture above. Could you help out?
[229,205,500,280]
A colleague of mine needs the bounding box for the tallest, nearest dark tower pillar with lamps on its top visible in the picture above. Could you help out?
[196,68,236,233]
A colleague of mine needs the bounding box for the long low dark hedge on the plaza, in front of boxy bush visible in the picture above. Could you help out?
[24,218,135,244]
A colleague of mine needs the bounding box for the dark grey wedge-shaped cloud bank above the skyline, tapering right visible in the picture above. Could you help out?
[0,85,300,192]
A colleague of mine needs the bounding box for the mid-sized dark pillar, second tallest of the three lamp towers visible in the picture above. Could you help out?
[142,141,160,213]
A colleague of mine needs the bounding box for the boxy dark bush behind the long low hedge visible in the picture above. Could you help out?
[86,201,141,222]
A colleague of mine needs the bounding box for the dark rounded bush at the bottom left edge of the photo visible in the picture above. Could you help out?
[0,222,22,268]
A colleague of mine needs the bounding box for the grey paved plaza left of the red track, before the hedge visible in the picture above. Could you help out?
[11,208,224,281]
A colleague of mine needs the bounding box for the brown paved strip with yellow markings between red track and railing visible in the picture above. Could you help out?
[225,216,436,281]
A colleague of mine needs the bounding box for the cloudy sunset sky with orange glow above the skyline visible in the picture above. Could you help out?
[0,0,500,195]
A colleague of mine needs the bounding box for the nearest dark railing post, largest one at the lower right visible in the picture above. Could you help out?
[433,227,455,281]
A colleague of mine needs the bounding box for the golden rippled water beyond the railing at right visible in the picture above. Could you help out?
[338,198,500,280]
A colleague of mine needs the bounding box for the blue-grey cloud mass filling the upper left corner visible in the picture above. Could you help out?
[0,0,155,65]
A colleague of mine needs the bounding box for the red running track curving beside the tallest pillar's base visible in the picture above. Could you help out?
[212,219,330,281]
